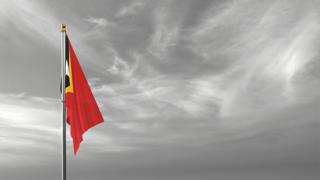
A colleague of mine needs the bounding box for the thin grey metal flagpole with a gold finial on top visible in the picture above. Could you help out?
[61,24,67,180]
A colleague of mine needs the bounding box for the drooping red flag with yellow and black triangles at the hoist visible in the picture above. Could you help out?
[65,35,103,155]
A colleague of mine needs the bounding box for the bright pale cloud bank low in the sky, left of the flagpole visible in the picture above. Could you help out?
[0,94,61,166]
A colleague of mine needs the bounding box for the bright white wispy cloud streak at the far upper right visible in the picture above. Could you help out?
[263,16,320,96]
